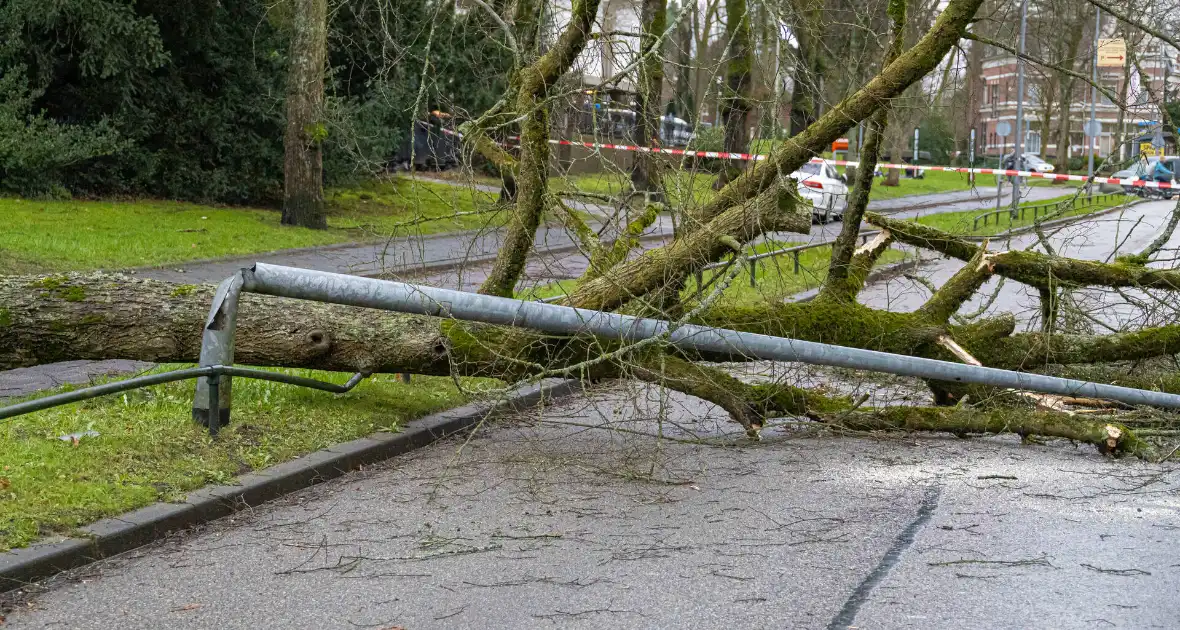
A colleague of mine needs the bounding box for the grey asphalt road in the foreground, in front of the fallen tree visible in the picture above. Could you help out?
[6,387,1180,630]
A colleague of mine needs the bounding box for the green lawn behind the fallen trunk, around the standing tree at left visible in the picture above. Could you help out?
[0,178,498,274]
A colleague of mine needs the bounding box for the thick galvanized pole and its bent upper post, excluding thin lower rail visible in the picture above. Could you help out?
[195,263,1180,420]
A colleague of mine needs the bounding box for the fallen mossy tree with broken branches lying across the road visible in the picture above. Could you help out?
[0,0,1180,455]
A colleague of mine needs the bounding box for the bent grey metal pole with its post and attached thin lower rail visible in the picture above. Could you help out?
[0,261,1180,435]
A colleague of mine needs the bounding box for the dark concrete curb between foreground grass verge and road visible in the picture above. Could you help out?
[0,381,579,592]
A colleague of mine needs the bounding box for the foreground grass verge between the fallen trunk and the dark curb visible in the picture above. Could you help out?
[0,366,488,551]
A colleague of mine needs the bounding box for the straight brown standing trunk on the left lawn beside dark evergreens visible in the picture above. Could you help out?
[282,0,328,230]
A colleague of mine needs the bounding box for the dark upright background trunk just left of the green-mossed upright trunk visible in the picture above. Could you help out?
[631,0,668,192]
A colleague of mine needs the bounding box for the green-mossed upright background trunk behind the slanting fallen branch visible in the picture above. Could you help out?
[716,0,754,189]
